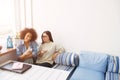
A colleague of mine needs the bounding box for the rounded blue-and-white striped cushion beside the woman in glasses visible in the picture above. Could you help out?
[55,52,79,66]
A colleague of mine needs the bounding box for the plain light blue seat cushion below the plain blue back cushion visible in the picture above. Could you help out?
[70,67,105,80]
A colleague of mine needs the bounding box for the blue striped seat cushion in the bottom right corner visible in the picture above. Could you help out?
[105,72,120,80]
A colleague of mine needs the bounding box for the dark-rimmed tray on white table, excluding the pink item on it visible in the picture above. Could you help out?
[0,60,32,74]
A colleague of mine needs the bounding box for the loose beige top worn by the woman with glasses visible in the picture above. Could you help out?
[36,42,65,64]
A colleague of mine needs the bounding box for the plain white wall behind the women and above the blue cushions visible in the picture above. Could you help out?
[33,0,120,55]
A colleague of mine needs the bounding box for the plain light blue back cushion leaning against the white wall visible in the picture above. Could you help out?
[79,51,108,72]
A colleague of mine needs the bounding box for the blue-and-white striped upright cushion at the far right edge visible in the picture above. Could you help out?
[107,56,120,73]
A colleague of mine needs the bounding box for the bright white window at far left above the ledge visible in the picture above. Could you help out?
[0,0,16,49]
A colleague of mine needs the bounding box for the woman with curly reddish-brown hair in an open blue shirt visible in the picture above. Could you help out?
[16,28,38,63]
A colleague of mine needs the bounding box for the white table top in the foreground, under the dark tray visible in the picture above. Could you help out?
[0,62,70,80]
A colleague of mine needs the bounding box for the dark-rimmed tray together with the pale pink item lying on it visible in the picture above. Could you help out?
[0,61,32,74]
